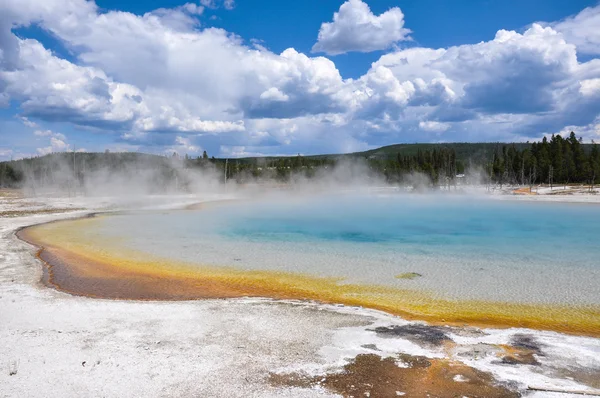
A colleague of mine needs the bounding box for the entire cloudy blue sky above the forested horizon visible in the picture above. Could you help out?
[0,0,600,160]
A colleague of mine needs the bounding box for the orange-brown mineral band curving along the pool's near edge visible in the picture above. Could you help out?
[12,219,600,337]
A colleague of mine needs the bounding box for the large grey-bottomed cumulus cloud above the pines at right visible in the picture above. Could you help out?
[449,24,577,113]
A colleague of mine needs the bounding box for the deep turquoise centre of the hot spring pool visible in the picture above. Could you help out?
[215,196,600,267]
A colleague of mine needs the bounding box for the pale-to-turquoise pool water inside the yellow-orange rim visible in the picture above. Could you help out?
[92,194,600,304]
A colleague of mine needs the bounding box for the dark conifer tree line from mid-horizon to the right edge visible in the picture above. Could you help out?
[196,132,600,185]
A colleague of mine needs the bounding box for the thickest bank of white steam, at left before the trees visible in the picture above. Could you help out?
[14,153,222,196]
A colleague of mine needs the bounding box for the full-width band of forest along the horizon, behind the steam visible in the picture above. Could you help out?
[0,132,600,188]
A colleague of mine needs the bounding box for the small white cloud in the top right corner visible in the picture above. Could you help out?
[551,5,600,55]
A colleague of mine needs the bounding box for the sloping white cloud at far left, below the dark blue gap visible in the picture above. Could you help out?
[4,40,244,133]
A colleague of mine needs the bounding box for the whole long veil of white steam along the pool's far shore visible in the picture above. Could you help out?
[4,153,489,197]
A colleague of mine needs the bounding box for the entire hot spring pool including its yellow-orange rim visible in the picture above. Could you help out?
[23,193,600,335]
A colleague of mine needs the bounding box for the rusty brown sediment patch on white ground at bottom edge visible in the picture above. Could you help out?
[269,354,521,398]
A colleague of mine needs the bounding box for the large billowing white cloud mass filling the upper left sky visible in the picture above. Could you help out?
[1,0,352,124]
